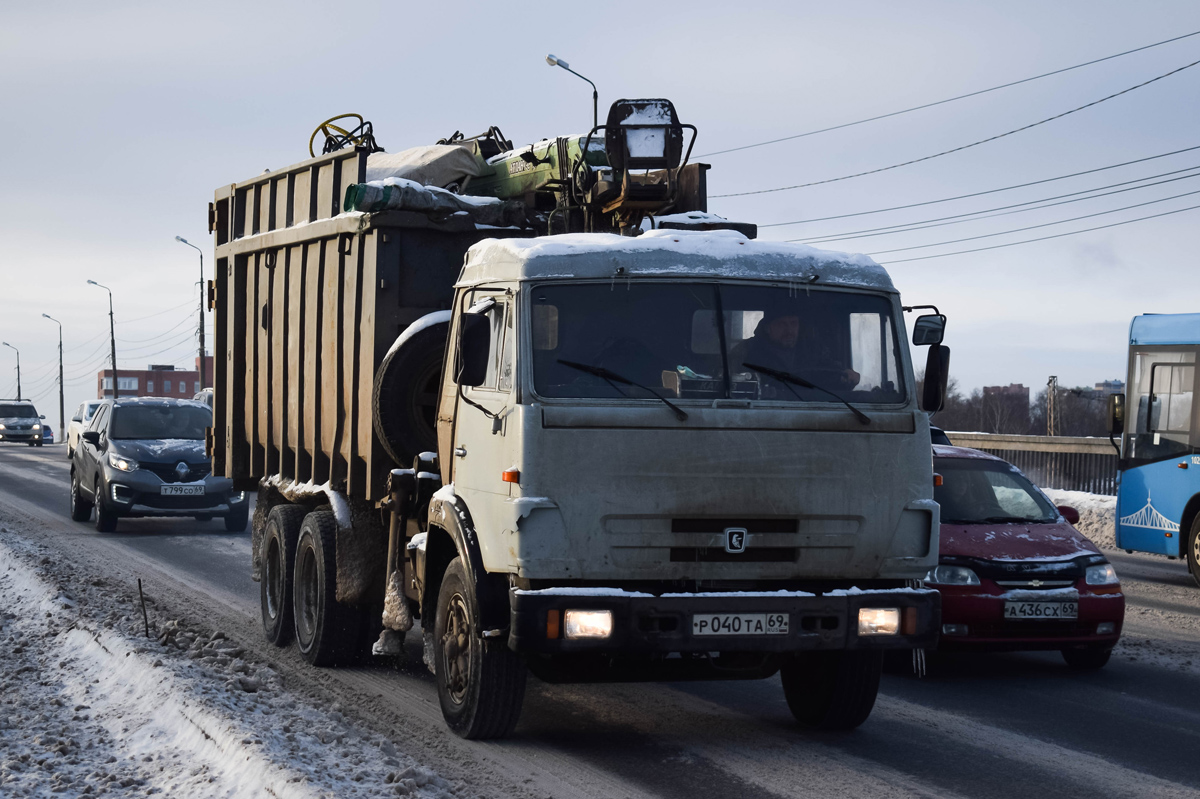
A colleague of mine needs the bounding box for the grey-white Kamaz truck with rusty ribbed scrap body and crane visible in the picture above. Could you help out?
[209,100,948,738]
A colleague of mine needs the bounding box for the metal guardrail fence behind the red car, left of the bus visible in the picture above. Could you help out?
[946,432,1117,495]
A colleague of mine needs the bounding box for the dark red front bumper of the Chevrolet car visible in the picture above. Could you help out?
[937,583,1124,651]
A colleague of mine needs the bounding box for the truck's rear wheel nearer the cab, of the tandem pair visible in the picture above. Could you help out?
[292,510,359,666]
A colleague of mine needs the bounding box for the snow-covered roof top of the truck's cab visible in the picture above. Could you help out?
[457,230,895,292]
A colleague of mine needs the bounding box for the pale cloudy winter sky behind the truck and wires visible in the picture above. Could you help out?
[0,0,1200,426]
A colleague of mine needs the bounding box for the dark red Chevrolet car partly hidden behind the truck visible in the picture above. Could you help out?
[925,446,1124,669]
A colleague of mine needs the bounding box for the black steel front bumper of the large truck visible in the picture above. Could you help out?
[509,588,941,654]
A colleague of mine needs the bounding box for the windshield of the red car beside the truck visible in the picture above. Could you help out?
[934,458,1058,524]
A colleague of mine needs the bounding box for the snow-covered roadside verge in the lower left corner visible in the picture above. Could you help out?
[0,528,461,799]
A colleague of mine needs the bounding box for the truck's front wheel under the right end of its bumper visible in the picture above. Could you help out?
[779,649,883,729]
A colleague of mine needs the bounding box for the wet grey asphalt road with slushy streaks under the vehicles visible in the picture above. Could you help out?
[0,445,1200,798]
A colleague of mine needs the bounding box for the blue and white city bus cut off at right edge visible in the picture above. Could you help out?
[1109,313,1200,584]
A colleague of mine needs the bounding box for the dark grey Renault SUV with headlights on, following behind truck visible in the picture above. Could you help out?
[71,398,250,533]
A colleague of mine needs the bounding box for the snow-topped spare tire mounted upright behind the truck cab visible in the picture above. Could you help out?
[371,311,450,468]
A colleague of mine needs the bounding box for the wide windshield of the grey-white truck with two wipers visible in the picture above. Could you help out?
[530,281,905,404]
